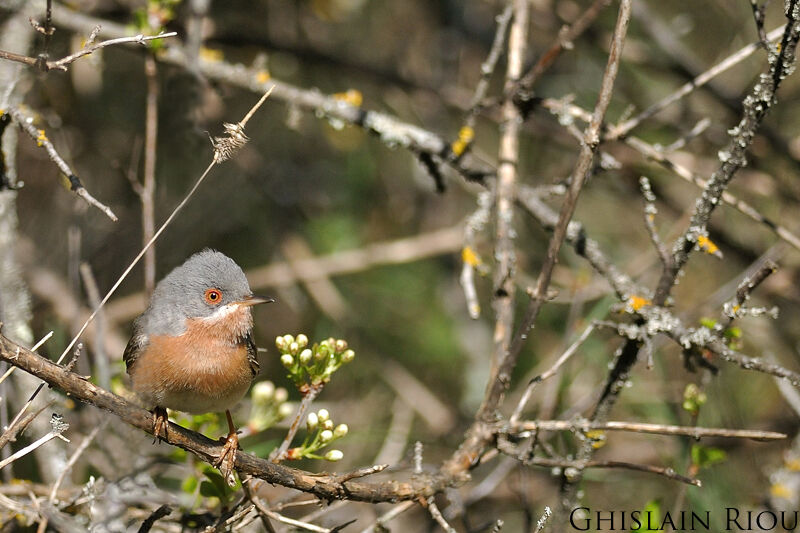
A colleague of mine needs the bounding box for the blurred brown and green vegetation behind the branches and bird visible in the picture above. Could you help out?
[0,0,800,531]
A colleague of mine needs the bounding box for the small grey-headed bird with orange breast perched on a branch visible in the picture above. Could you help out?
[123,249,274,481]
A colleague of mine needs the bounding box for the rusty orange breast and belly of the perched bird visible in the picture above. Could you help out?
[131,319,252,413]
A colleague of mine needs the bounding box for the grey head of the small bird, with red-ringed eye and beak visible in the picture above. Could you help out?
[139,249,264,335]
